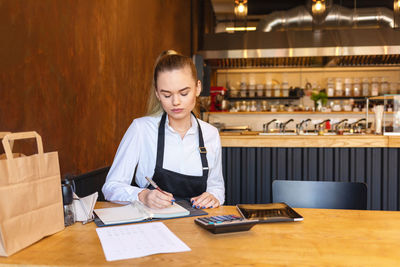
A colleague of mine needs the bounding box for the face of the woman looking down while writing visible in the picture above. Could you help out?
[156,66,201,121]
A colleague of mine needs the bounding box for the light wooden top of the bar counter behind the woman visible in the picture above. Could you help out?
[221,133,400,147]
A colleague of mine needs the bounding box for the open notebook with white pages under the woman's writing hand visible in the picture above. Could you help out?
[94,201,190,225]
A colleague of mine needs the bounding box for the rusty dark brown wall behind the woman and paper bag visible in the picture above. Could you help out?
[0,0,191,174]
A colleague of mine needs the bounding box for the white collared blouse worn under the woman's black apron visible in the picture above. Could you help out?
[102,115,225,205]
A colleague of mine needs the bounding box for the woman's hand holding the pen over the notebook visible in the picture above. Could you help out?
[138,188,174,209]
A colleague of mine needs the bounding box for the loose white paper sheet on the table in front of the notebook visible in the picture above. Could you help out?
[96,222,190,261]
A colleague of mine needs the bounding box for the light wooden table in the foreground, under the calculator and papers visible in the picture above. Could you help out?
[0,203,400,266]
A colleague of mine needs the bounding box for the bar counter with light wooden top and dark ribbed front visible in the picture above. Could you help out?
[221,132,400,210]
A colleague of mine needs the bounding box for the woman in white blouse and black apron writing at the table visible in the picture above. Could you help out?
[102,50,225,209]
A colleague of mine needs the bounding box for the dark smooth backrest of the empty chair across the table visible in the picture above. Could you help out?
[272,180,367,210]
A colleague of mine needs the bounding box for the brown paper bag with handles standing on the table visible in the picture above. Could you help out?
[0,132,64,256]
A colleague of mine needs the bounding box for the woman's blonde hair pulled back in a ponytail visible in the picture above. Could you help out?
[146,50,197,116]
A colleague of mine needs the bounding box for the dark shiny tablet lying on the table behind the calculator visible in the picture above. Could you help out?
[236,203,303,223]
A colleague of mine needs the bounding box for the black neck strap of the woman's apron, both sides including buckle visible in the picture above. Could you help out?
[156,112,209,177]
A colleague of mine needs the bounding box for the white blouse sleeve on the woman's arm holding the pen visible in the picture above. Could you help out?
[102,121,143,202]
